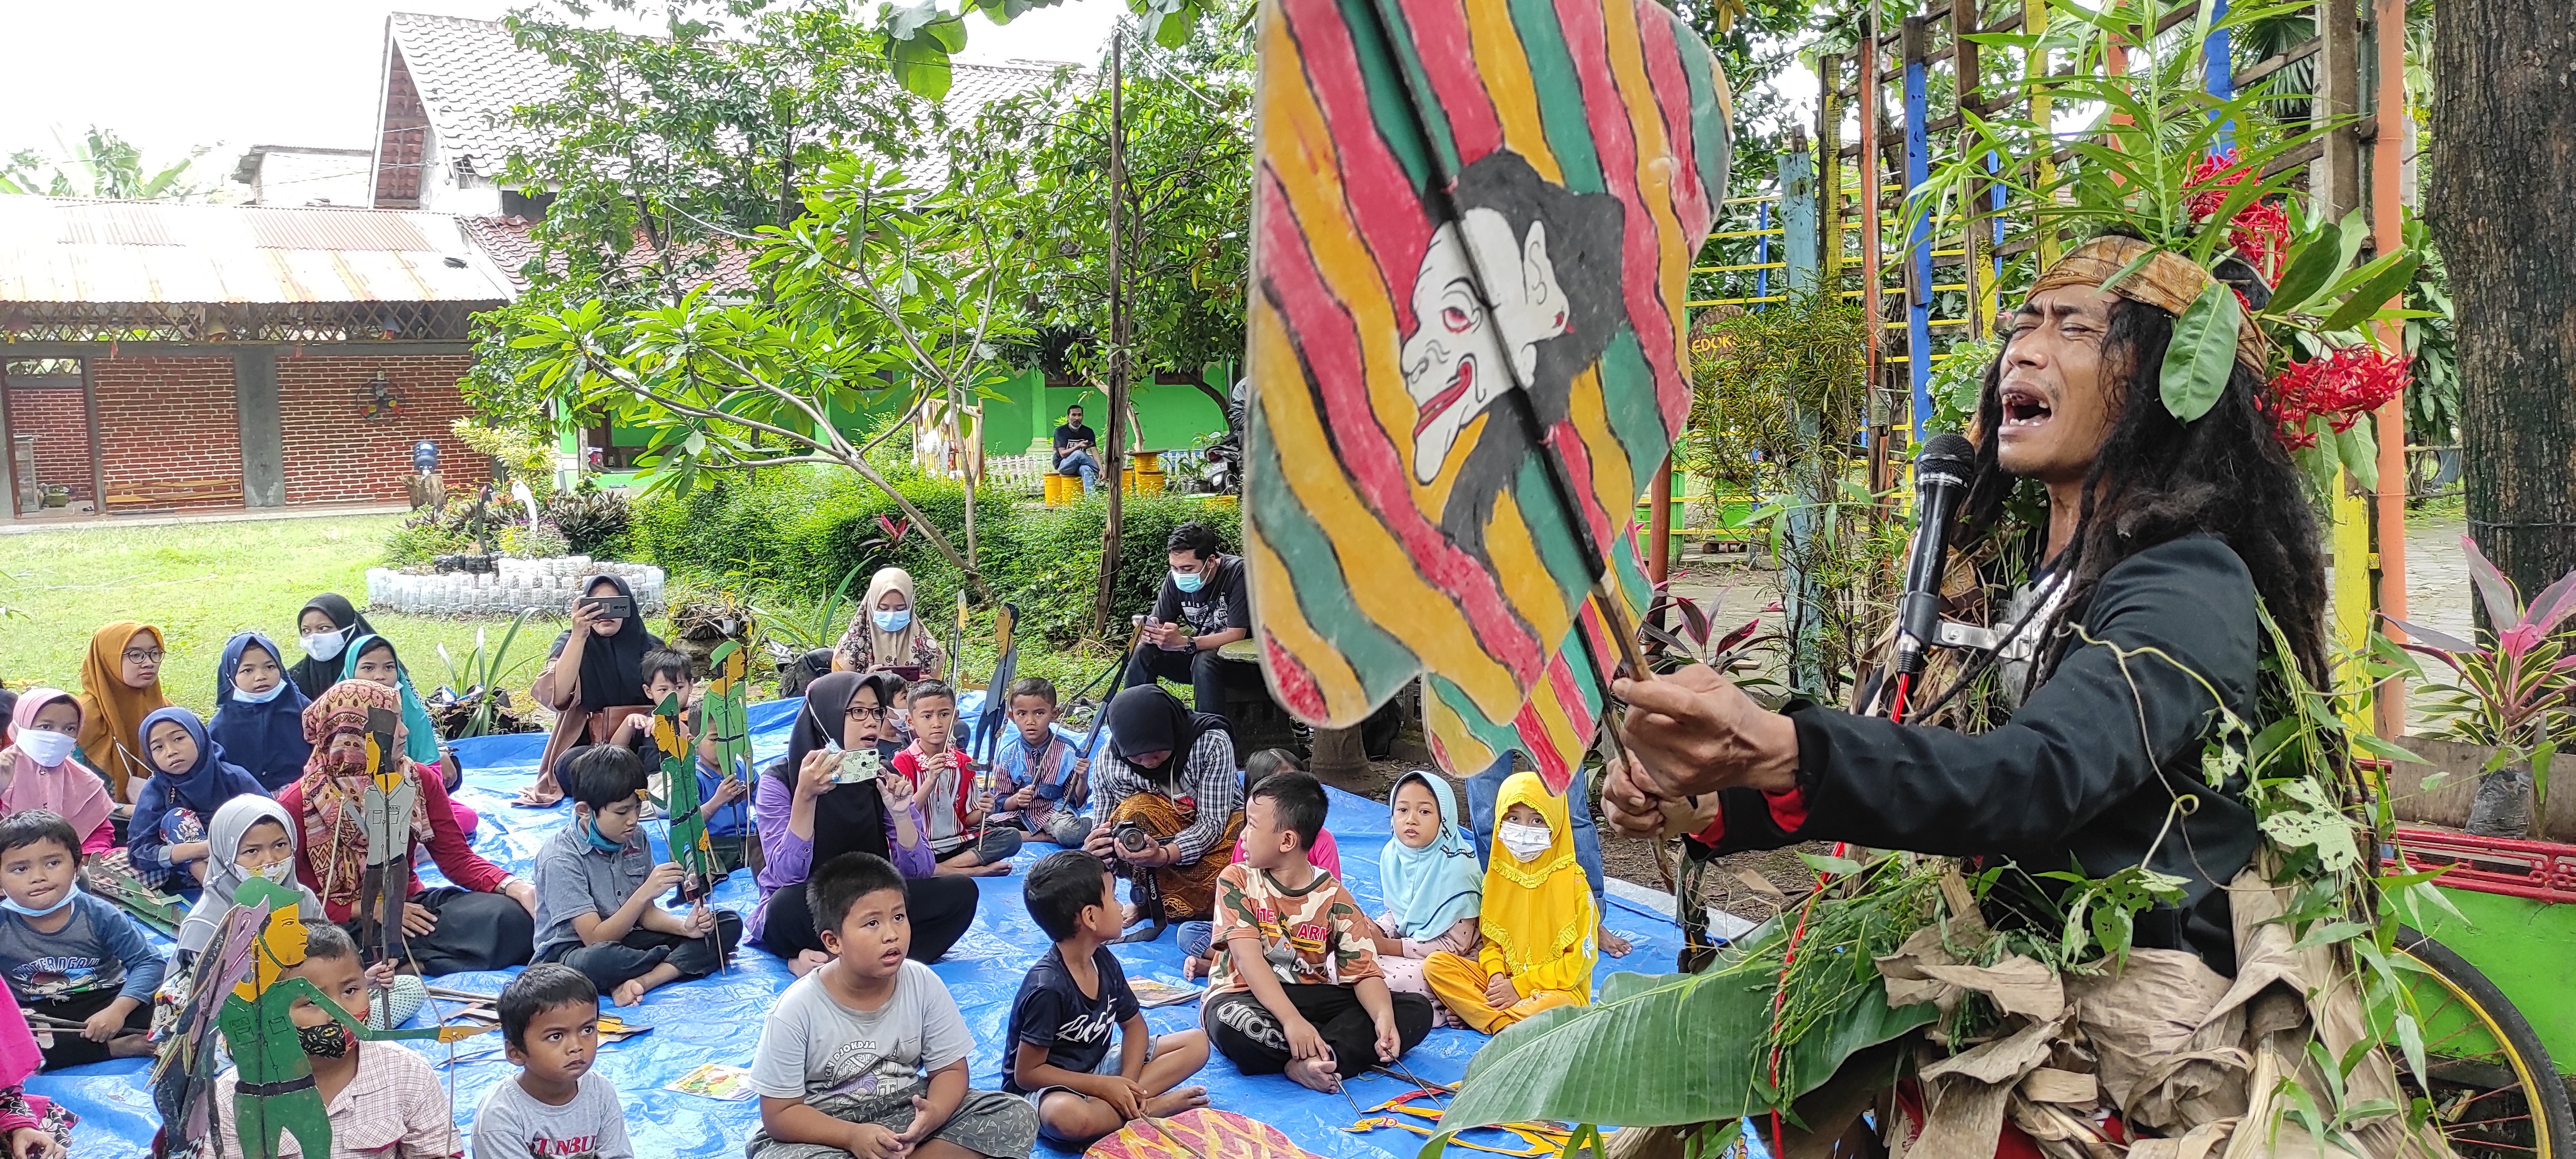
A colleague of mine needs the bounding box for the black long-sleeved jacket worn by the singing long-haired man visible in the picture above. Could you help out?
[1692,536,2262,976]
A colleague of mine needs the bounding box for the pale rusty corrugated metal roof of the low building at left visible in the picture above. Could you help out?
[0,196,512,304]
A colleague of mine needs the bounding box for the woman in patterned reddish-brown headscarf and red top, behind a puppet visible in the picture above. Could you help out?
[278,680,536,974]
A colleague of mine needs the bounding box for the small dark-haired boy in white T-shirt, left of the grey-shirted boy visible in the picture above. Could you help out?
[474,963,636,1159]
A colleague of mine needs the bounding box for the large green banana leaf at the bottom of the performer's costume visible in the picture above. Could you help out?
[1422,971,1940,1143]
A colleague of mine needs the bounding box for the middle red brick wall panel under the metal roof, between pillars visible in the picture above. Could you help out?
[90,355,242,512]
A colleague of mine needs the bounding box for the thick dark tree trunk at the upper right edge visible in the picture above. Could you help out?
[2424,0,2576,608]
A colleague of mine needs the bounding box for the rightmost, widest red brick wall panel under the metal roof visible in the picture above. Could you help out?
[278,353,490,505]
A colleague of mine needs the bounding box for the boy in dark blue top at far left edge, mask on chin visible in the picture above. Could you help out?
[0,808,162,1071]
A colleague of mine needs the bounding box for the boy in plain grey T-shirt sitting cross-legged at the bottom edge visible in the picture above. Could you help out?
[744,853,1038,1159]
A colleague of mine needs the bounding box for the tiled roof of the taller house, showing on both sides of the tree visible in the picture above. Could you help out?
[386,13,1056,183]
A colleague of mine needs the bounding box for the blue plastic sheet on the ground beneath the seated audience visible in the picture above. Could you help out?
[45,693,1682,1159]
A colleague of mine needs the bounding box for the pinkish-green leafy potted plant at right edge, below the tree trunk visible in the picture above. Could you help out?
[2388,536,2576,837]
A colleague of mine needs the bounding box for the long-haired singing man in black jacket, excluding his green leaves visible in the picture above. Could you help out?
[1602,234,2437,1156]
